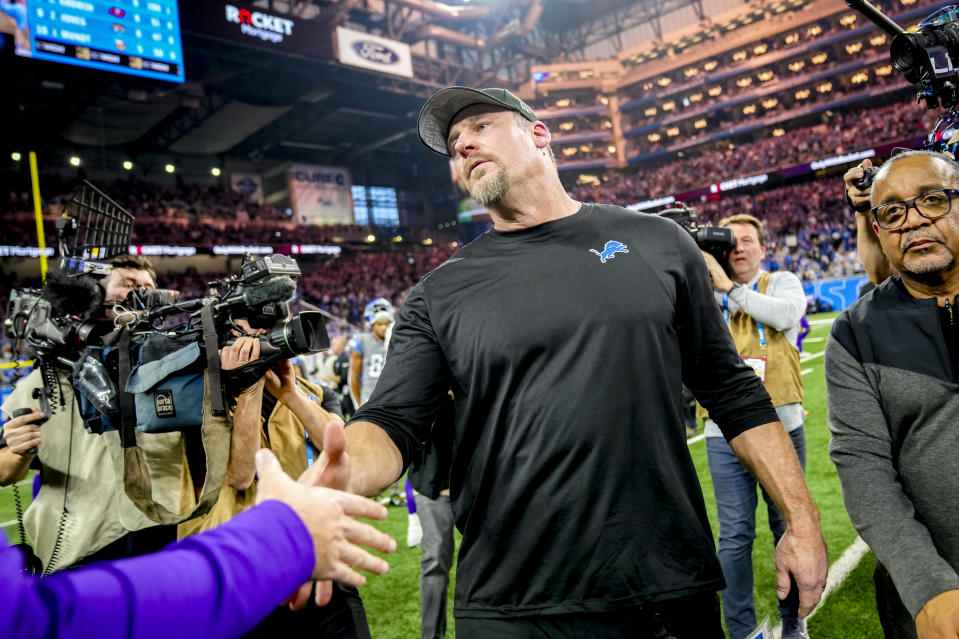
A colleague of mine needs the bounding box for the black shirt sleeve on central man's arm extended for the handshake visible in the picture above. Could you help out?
[351,276,453,468]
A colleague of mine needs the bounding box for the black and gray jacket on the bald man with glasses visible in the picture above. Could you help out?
[826,277,959,616]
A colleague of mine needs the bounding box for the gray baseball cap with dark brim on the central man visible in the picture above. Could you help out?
[416,87,537,157]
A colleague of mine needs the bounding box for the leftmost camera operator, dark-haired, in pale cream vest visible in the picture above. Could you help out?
[0,256,179,573]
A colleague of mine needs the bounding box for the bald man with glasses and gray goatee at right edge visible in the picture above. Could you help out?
[826,151,959,639]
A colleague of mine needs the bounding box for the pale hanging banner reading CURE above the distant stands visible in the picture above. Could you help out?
[289,164,353,224]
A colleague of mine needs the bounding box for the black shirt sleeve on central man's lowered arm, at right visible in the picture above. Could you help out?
[676,226,779,441]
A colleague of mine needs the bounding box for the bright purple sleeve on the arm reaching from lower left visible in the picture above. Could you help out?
[0,501,314,639]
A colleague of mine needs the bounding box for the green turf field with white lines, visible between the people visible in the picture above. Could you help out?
[0,313,882,639]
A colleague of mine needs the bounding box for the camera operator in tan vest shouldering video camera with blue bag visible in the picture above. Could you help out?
[179,319,370,638]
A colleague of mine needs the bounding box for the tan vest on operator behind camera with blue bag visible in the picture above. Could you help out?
[177,377,323,539]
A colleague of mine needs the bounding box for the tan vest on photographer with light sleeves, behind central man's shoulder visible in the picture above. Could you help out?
[696,272,803,417]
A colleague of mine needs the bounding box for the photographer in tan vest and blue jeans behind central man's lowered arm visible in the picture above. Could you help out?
[701,215,808,639]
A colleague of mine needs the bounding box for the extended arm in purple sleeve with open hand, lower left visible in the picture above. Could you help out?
[0,451,396,639]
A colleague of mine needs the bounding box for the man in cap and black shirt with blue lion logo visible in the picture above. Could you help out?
[312,87,827,639]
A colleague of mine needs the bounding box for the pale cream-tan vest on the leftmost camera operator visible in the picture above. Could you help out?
[3,370,172,572]
